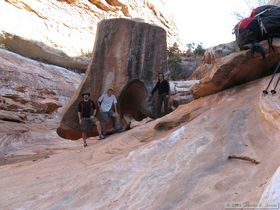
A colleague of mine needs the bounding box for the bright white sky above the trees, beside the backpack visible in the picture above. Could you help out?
[168,0,266,48]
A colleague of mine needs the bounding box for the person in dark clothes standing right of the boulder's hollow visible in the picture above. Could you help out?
[152,73,170,117]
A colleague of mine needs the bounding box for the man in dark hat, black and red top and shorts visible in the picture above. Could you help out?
[78,93,104,147]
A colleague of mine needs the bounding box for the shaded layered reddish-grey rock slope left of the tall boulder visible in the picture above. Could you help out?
[0,49,81,164]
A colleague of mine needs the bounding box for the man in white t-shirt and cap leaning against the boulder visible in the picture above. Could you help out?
[98,87,119,134]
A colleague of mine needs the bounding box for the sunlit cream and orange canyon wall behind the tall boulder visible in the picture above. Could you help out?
[0,0,181,68]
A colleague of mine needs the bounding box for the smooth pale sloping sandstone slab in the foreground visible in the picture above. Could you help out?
[0,73,280,210]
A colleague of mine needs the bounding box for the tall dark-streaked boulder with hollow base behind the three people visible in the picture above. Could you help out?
[58,18,167,139]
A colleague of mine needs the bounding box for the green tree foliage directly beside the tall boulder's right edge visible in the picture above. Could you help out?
[167,42,182,80]
